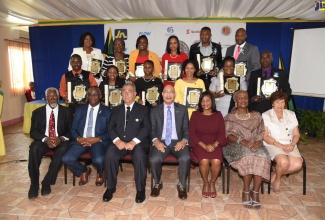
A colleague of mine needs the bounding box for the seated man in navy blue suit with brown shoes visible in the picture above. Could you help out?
[62,87,111,186]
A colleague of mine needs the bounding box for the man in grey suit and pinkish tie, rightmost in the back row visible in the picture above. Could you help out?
[226,28,261,82]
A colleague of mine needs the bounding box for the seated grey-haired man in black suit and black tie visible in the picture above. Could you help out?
[103,84,151,203]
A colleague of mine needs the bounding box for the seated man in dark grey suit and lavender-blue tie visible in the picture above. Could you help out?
[149,85,190,199]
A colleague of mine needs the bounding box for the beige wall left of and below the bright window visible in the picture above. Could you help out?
[0,27,26,125]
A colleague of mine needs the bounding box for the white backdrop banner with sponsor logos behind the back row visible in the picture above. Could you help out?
[104,22,246,58]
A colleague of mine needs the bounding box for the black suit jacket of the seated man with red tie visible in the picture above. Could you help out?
[29,105,72,141]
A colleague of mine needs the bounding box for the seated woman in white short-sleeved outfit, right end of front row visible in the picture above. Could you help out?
[262,91,302,193]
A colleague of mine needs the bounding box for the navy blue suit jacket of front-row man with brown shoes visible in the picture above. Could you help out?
[71,104,111,145]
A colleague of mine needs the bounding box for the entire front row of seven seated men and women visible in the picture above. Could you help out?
[28,84,302,209]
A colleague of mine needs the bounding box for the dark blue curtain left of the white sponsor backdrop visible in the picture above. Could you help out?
[29,25,105,99]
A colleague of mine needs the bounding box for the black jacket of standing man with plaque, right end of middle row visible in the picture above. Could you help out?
[247,67,292,113]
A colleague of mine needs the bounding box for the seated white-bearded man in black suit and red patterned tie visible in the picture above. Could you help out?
[28,88,72,199]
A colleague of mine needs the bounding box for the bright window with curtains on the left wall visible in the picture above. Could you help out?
[8,40,34,96]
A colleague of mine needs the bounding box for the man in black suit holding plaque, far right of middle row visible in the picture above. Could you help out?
[248,50,291,114]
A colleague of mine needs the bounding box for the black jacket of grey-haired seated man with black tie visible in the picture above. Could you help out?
[108,102,151,142]
